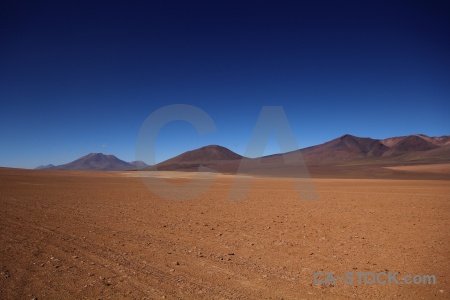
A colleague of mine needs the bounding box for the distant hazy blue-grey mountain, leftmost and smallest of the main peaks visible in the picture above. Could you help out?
[51,153,136,171]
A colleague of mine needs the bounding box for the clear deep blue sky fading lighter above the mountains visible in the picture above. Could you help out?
[0,0,450,168]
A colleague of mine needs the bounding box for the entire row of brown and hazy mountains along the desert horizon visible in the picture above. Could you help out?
[34,134,450,176]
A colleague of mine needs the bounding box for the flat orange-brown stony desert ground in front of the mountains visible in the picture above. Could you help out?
[0,169,450,299]
